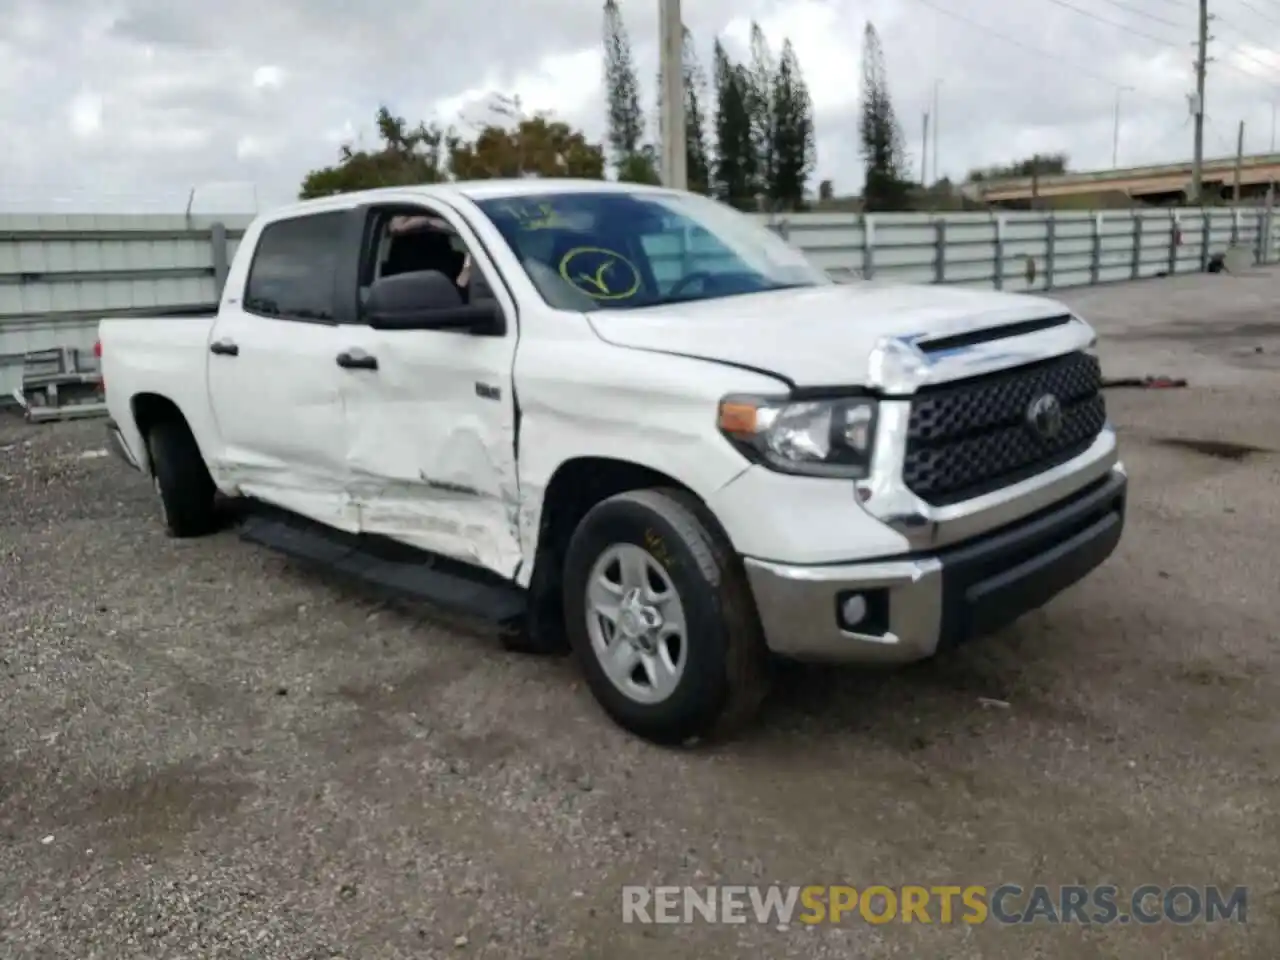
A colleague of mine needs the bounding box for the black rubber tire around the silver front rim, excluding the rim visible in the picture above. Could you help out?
[563,489,768,745]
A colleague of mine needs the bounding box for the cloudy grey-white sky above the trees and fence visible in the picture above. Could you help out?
[0,0,1280,212]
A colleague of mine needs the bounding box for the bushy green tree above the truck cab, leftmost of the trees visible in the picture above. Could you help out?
[298,106,458,200]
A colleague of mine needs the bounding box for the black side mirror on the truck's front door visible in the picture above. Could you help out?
[364,270,506,337]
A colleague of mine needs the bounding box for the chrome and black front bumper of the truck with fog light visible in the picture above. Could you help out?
[745,465,1128,663]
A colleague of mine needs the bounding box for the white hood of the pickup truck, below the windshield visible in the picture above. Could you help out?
[586,283,1070,387]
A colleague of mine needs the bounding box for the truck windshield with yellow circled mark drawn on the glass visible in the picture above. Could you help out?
[477,191,832,311]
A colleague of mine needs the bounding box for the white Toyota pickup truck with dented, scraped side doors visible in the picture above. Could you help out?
[100,180,1126,742]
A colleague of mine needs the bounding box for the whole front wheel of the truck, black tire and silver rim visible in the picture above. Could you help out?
[563,490,767,744]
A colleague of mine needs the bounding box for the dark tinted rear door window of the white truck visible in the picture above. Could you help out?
[244,210,346,320]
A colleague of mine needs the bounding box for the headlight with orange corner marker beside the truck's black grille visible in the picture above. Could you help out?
[718,397,876,479]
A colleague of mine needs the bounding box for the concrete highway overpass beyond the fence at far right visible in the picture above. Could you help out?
[964,154,1280,207]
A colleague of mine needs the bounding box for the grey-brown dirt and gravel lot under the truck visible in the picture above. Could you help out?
[0,276,1280,960]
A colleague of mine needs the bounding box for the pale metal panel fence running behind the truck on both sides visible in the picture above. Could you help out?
[0,207,1277,398]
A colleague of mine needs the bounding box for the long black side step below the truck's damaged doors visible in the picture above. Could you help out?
[241,507,527,626]
